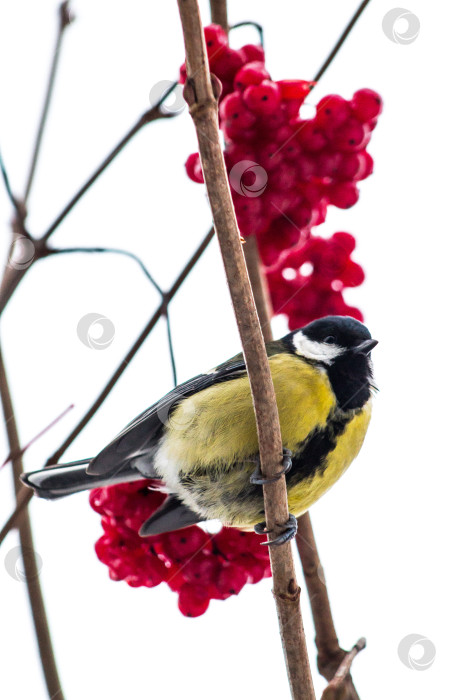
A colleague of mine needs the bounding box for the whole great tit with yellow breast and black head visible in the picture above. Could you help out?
[22,316,378,544]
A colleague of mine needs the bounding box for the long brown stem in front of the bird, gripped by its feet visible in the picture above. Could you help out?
[178,0,315,700]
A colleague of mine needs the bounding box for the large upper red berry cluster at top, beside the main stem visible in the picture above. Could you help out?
[181,25,382,265]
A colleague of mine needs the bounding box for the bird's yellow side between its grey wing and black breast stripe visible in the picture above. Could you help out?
[164,353,336,471]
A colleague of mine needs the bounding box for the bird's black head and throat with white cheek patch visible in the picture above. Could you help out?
[286,316,378,410]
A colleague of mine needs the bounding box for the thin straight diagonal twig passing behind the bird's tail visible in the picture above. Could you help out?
[0,228,214,544]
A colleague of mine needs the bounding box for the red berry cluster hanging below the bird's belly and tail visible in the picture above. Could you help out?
[90,480,271,617]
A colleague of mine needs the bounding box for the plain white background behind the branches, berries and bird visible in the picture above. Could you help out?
[0,0,467,700]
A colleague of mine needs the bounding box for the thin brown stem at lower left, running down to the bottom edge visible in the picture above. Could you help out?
[0,348,64,700]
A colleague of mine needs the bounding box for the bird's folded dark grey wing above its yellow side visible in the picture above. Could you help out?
[87,355,246,478]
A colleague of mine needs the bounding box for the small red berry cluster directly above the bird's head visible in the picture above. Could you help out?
[266,231,364,330]
